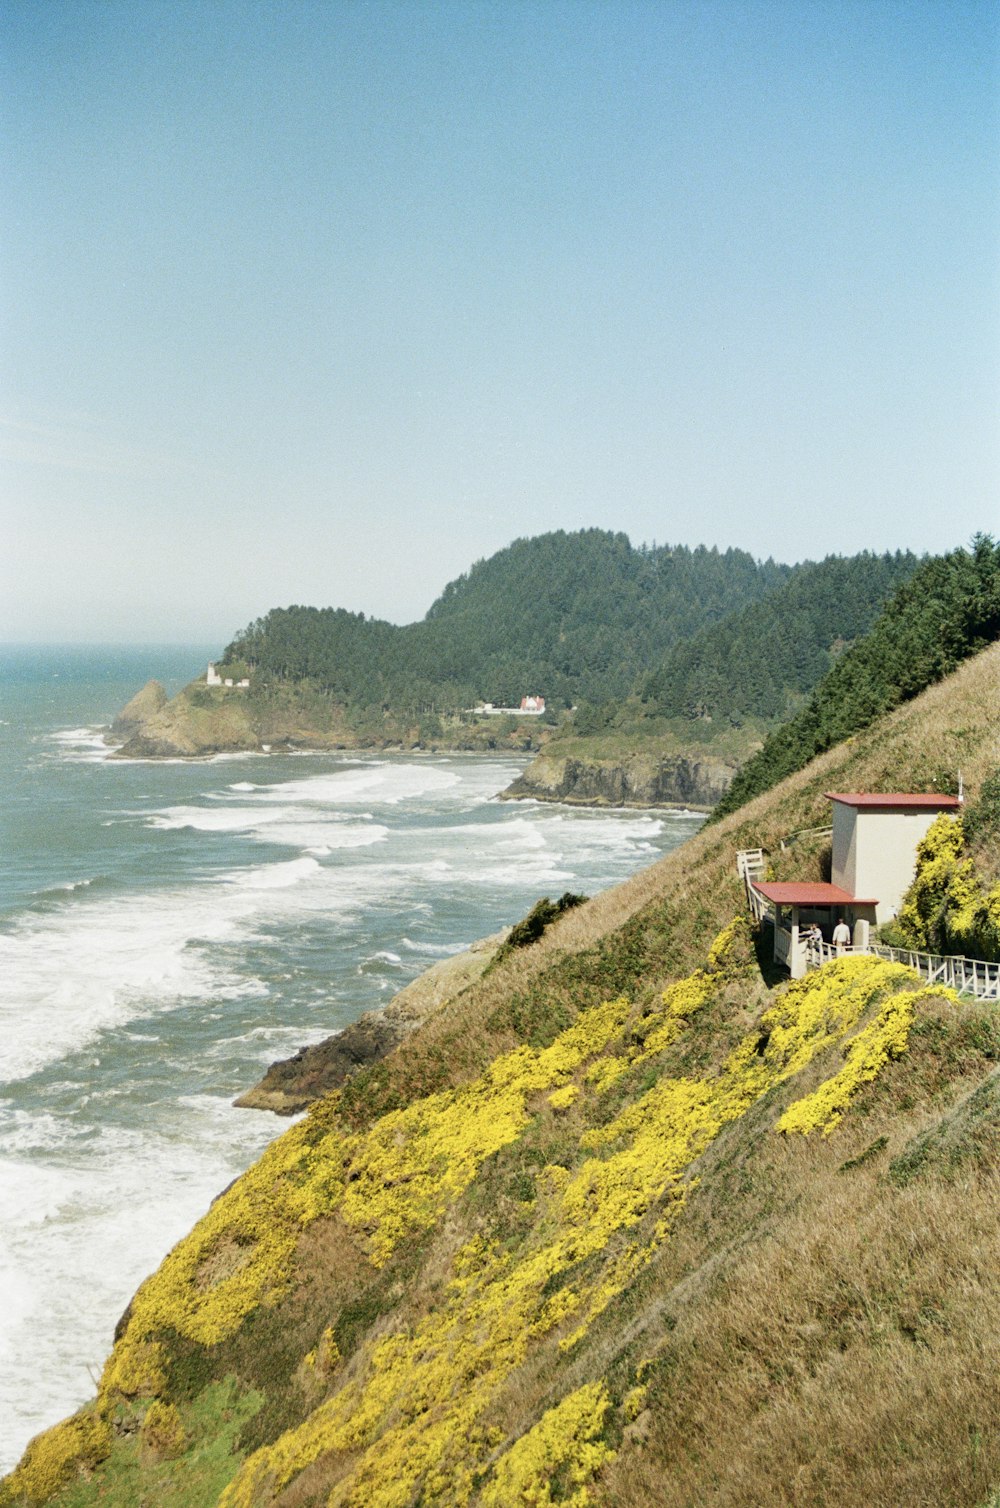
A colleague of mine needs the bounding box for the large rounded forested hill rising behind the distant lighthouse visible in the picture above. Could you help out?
[225,529,798,710]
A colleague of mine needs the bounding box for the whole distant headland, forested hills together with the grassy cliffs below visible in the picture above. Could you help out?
[116,529,916,772]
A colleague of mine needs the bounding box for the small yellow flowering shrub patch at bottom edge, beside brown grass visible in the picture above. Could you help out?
[480,1383,614,1508]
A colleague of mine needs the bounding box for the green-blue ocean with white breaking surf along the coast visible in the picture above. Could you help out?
[0,645,701,1472]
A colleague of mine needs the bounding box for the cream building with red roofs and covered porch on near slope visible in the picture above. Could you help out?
[748,792,961,979]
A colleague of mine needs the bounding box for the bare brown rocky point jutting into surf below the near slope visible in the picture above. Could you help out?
[234,929,510,1116]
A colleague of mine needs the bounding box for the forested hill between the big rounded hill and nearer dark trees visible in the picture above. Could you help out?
[643,550,919,721]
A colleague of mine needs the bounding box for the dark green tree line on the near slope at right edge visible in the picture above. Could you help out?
[712,535,1000,819]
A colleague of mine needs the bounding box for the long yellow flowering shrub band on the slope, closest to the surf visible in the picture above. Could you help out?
[101,1000,629,1399]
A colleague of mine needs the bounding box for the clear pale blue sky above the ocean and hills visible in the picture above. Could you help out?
[0,0,1000,642]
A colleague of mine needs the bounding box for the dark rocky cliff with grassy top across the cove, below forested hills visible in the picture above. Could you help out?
[504,756,738,807]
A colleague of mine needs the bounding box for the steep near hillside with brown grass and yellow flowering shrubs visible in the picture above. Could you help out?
[7,645,1000,1508]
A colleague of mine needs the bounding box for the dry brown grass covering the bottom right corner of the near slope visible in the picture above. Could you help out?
[596,1016,1000,1508]
